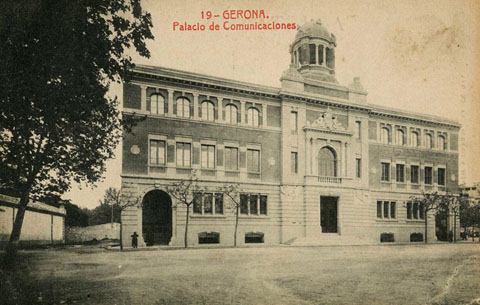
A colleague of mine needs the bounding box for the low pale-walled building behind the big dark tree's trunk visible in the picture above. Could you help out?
[0,194,66,249]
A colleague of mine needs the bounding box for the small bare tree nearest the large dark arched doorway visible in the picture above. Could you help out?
[166,171,205,248]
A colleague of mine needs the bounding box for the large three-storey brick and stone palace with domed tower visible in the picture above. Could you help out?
[118,20,460,246]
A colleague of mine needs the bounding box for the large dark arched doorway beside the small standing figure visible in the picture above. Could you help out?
[142,190,172,246]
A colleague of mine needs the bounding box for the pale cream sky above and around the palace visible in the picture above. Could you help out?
[63,0,480,208]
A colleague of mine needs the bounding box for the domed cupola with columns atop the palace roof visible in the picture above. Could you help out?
[290,19,337,83]
